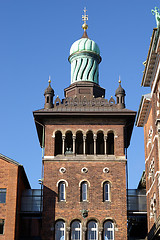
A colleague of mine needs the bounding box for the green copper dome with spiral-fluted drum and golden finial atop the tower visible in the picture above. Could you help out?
[69,8,101,84]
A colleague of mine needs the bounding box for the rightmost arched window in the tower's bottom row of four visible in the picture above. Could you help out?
[103,221,114,240]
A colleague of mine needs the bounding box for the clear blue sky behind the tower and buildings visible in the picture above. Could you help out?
[0,0,160,188]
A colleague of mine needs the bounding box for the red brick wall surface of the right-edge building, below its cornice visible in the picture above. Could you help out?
[144,93,160,231]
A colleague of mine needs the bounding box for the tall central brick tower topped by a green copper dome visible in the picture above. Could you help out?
[33,8,136,240]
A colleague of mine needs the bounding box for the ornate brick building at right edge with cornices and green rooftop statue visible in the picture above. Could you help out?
[136,8,160,239]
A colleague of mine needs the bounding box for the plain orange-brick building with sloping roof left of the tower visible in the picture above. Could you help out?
[0,154,30,240]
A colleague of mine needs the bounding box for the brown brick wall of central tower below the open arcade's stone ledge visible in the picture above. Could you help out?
[42,158,127,240]
